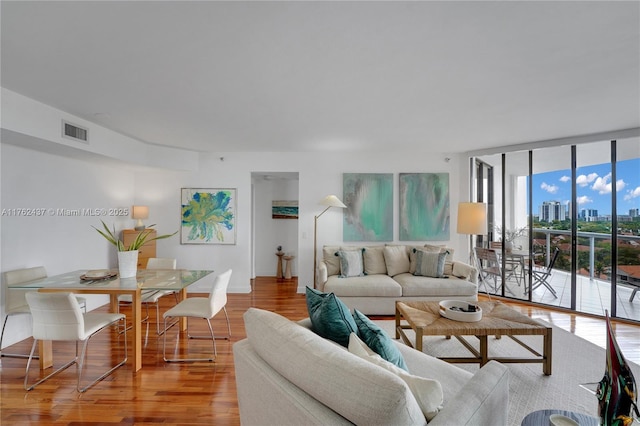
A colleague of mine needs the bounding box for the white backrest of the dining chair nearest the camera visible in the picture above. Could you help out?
[26,291,87,340]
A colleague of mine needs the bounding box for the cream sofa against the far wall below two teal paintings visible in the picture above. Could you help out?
[316,244,478,315]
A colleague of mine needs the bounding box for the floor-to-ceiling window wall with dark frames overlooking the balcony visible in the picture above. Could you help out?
[473,138,640,321]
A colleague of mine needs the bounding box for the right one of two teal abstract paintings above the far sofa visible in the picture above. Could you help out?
[398,173,449,241]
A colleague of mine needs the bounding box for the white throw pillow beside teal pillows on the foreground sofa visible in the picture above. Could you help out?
[349,333,444,422]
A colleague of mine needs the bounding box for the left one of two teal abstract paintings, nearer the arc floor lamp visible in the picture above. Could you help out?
[342,173,393,241]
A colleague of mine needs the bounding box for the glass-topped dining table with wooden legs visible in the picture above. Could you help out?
[8,269,214,372]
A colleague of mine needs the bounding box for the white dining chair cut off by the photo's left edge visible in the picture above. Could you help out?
[0,266,87,358]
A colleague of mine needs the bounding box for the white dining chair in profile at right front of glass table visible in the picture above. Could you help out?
[162,269,232,362]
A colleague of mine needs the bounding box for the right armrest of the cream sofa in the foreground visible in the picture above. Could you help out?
[429,361,509,426]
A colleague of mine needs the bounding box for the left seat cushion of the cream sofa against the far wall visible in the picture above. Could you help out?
[324,274,402,297]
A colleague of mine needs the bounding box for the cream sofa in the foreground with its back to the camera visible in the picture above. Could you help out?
[233,308,509,426]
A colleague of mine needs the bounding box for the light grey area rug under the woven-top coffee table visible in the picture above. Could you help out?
[375,320,640,426]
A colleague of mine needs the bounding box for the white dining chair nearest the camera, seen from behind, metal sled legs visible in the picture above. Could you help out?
[24,291,127,392]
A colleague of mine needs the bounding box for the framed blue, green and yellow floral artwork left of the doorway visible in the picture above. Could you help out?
[180,188,237,244]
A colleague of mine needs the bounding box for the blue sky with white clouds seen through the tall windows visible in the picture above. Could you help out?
[533,158,640,216]
